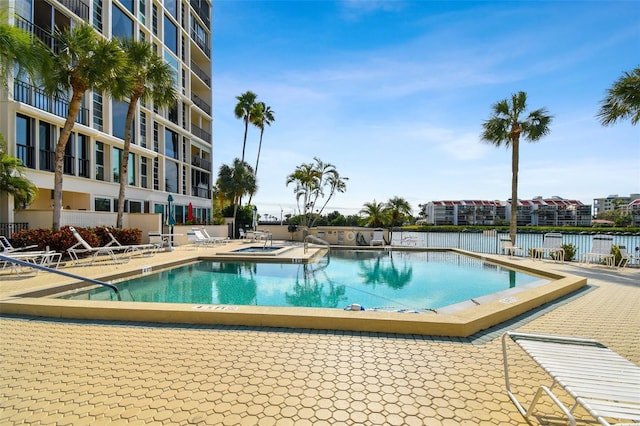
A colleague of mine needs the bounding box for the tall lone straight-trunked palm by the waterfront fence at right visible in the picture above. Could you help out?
[482,91,553,245]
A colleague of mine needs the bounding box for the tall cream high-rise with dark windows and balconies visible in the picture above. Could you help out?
[0,0,213,223]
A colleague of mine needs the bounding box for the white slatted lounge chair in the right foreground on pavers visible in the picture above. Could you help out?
[502,332,640,426]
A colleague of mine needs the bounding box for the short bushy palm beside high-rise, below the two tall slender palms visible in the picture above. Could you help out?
[216,158,257,236]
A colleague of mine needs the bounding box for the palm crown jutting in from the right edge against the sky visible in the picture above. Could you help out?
[597,67,640,126]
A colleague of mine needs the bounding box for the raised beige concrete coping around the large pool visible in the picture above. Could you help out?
[0,247,587,337]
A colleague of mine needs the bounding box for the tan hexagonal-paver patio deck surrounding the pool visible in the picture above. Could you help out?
[0,246,640,425]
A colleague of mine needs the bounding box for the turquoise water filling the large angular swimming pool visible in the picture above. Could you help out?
[63,250,545,311]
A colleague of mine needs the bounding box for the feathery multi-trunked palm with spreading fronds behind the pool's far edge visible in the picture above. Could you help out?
[287,157,349,227]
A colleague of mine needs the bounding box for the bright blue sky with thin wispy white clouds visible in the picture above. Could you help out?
[213,0,640,217]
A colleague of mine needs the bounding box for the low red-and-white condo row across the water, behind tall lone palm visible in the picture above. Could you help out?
[426,197,592,226]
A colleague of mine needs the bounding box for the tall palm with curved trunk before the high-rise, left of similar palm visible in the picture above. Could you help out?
[40,23,126,231]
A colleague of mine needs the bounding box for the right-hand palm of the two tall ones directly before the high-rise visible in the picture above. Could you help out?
[112,40,177,228]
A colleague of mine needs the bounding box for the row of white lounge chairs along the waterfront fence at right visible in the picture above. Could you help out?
[500,232,632,268]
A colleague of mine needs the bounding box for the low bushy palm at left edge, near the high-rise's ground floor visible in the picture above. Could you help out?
[0,135,38,208]
